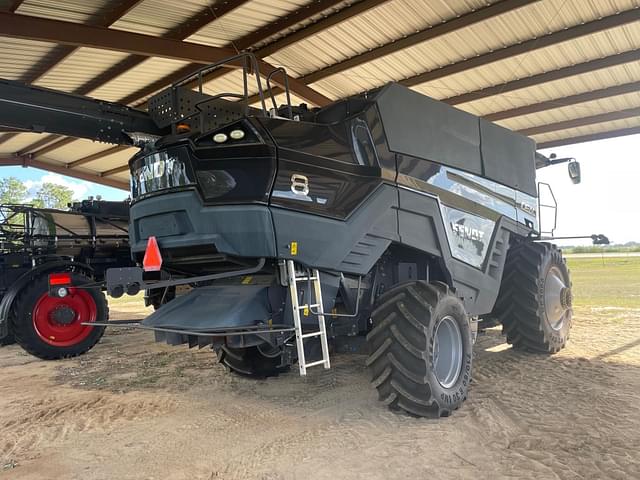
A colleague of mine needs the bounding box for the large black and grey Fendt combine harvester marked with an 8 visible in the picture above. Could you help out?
[0,54,592,416]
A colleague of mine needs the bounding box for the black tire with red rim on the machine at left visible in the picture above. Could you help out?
[10,273,109,360]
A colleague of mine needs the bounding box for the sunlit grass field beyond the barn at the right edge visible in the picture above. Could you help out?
[567,257,640,308]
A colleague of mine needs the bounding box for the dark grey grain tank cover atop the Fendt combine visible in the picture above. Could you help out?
[373,83,537,196]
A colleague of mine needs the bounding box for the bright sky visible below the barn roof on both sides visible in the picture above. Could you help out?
[0,135,640,245]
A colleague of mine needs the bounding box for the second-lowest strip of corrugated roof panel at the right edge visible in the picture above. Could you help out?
[497,92,640,130]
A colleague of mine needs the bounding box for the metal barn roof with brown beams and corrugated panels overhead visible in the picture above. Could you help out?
[0,0,640,189]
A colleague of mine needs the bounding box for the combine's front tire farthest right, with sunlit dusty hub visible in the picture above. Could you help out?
[494,242,573,353]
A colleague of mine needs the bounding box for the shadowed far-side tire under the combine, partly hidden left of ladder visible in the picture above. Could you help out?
[216,345,289,378]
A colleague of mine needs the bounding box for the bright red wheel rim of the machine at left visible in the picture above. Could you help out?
[31,288,97,347]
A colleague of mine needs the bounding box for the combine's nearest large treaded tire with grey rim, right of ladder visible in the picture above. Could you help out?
[367,281,472,417]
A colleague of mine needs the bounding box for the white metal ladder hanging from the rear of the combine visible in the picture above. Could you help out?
[287,260,331,375]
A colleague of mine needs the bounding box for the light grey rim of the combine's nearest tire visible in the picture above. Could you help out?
[433,316,462,388]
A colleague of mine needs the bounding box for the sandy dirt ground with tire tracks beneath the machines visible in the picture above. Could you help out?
[0,258,640,480]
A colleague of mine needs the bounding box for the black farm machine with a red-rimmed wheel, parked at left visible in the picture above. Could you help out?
[0,199,133,359]
